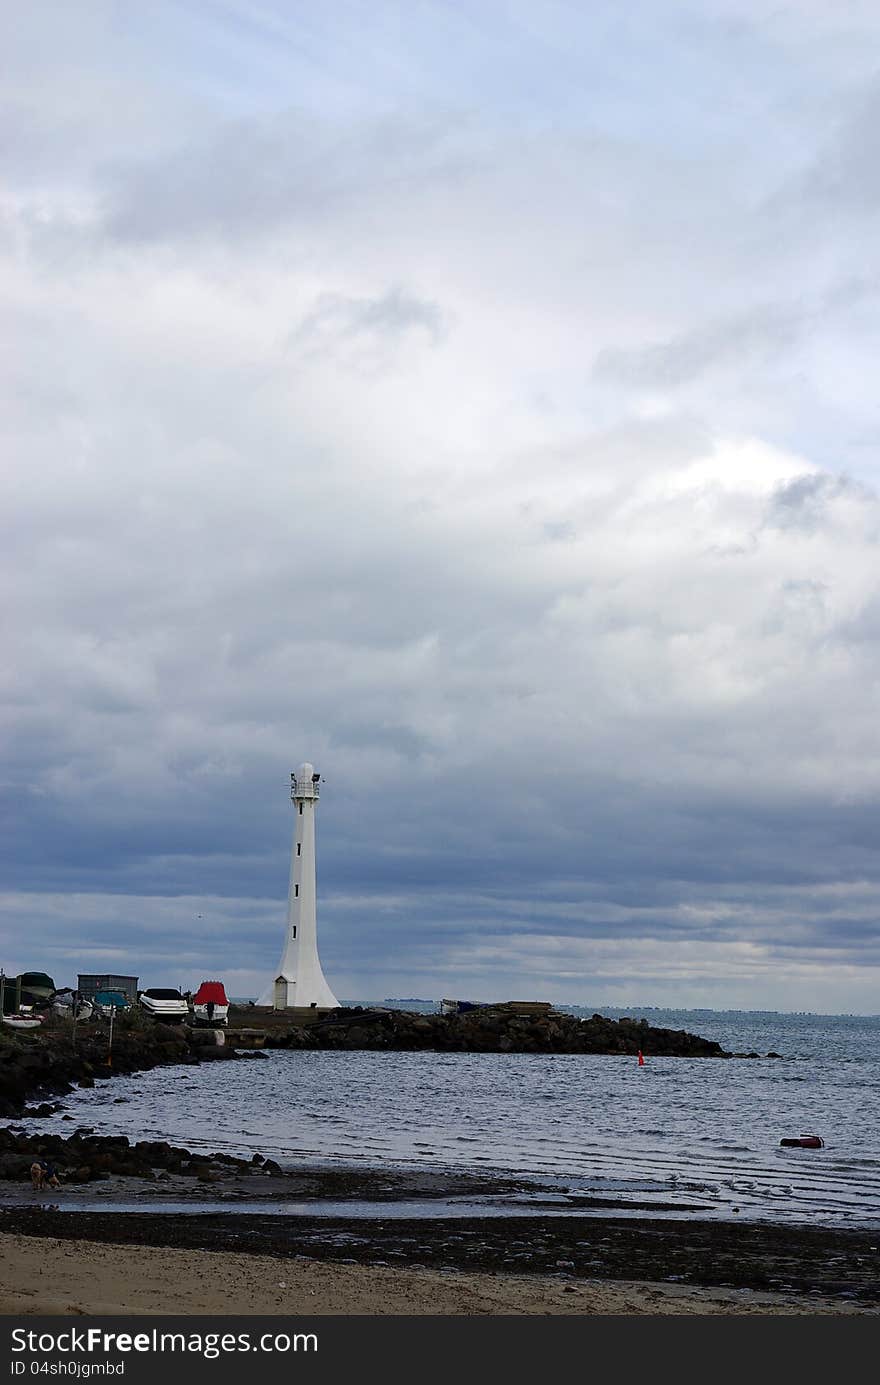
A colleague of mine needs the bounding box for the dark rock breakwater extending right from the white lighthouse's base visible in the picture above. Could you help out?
[266,1004,733,1058]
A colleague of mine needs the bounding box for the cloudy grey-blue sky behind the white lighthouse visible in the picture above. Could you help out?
[0,0,880,1014]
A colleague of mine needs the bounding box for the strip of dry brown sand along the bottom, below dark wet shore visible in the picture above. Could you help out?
[0,1234,877,1317]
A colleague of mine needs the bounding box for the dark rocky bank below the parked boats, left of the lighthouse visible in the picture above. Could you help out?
[0,1021,240,1119]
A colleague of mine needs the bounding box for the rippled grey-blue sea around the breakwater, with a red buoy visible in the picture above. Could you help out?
[13,1003,880,1228]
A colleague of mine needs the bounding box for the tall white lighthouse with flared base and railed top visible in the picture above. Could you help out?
[258,763,340,1010]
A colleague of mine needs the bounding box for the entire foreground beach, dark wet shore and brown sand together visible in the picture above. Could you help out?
[0,1168,880,1316]
